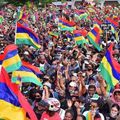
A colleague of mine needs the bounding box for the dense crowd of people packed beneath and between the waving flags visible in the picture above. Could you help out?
[0,3,120,120]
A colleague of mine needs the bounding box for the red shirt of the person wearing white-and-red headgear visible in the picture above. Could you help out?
[40,112,61,120]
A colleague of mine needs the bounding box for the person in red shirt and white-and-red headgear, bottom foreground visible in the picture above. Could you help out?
[40,98,61,120]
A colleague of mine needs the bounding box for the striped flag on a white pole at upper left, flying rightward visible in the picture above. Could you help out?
[15,23,40,49]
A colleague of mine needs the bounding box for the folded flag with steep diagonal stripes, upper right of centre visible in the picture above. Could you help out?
[87,26,101,51]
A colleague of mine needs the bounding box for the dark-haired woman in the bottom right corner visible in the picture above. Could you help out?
[105,104,120,120]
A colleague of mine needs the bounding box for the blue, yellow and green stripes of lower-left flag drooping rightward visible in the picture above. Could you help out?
[12,65,42,86]
